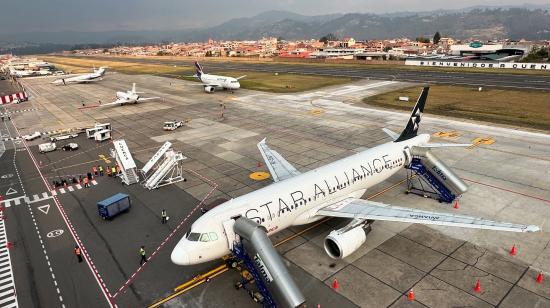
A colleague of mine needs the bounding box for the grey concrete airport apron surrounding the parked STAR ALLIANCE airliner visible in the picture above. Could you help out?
[0,73,550,307]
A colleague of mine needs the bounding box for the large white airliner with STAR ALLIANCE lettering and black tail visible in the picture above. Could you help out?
[171,87,540,265]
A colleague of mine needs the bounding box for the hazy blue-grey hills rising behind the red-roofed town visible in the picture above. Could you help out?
[0,5,550,44]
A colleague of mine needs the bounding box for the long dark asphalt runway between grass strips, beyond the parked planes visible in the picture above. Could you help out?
[76,56,550,90]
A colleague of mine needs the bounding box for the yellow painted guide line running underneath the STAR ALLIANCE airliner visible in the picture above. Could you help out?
[149,179,407,308]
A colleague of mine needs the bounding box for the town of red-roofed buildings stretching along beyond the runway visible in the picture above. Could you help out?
[65,33,550,61]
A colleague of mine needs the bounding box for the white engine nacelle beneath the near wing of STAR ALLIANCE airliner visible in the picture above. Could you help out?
[324,226,367,259]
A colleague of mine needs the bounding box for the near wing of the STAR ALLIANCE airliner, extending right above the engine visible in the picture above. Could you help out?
[316,198,540,232]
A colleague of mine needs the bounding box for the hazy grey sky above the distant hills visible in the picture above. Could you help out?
[0,0,550,33]
